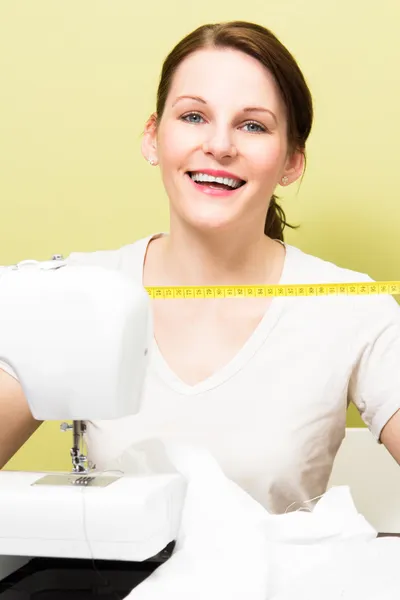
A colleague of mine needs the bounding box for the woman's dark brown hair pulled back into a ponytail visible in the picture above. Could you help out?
[156,21,313,241]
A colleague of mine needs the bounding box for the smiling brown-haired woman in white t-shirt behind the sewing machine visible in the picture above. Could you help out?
[0,22,400,513]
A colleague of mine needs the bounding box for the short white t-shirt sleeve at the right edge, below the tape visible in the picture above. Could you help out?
[349,296,400,441]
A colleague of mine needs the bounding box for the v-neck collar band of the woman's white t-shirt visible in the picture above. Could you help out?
[133,233,291,396]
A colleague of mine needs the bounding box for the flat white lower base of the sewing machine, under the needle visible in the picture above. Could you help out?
[0,471,186,564]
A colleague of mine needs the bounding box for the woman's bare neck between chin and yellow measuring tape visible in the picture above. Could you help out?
[157,220,284,285]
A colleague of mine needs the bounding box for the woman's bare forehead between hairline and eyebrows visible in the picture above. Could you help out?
[169,48,281,112]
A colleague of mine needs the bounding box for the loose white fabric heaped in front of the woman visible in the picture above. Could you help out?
[119,446,400,600]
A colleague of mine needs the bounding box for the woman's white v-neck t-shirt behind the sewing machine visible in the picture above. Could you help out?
[0,236,400,512]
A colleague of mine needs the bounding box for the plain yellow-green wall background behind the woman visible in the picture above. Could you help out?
[0,0,400,469]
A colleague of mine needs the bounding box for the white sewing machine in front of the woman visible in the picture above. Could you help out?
[0,257,186,580]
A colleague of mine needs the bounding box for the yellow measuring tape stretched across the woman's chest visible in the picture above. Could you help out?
[146,281,400,299]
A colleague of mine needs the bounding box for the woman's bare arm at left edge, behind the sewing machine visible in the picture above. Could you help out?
[0,369,41,469]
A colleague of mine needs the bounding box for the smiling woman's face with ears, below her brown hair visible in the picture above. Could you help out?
[142,49,303,230]
